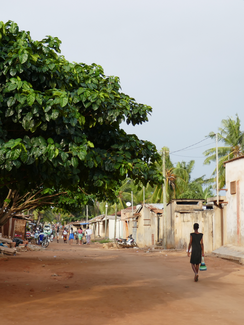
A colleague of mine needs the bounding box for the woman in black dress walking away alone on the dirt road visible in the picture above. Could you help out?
[188,223,204,282]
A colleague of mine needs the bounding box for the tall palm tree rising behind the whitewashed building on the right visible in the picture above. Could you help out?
[204,114,244,188]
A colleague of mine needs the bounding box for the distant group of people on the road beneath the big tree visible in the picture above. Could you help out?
[56,226,92,245]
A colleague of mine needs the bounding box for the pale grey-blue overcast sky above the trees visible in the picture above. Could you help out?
[0,0,244,182]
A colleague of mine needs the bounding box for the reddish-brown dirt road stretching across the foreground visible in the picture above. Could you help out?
[0,243,244,325]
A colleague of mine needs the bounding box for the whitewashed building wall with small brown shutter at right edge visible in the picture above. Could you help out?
[225,157,244,246]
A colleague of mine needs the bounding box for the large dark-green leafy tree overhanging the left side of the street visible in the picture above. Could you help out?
[0,21,162,225]
